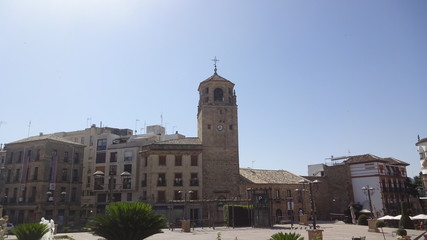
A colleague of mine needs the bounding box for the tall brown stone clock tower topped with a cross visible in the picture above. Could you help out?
[197,61,239,199]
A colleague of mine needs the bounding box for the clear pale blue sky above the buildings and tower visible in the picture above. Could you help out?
[0,0,427,177]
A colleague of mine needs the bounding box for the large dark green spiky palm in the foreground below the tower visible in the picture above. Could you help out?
[88,202,166,240]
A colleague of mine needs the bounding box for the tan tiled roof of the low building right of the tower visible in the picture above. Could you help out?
[240,168,307,184]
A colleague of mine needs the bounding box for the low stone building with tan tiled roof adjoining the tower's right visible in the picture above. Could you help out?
[239,168,317,227]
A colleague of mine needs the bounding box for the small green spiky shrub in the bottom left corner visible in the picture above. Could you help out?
[12,223,50,240]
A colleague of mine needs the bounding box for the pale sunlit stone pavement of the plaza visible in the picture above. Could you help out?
[7,222,425,240]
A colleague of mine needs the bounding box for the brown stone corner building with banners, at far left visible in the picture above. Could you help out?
[1,135,84,227]
